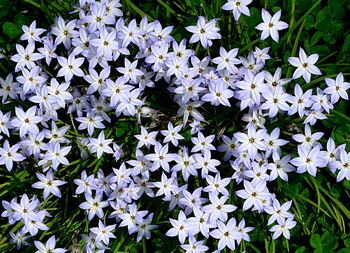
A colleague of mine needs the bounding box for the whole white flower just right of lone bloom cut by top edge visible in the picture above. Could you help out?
[255,9,288,42]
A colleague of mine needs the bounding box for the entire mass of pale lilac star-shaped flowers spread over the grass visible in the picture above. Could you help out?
[0,0,350,252]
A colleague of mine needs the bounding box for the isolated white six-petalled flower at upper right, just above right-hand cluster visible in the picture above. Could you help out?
[288,48,322,83]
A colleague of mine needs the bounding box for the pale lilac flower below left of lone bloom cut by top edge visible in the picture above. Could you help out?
[185,16,221,48]
